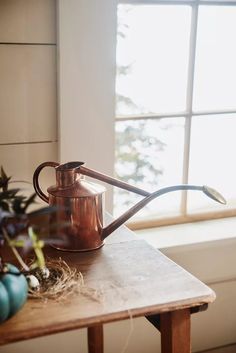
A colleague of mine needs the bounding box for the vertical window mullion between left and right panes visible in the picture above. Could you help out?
[181,5,198,215]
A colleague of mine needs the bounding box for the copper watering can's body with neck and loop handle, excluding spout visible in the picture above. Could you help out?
[33,162,106,251]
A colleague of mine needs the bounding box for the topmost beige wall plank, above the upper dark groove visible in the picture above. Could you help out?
[0,0,56,43]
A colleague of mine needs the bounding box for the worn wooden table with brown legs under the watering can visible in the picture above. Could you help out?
[0,227,215,353]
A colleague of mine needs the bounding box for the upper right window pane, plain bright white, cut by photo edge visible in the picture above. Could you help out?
[193,6,236,111]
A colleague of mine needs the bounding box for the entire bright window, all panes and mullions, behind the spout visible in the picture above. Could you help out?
[114,0,236,228]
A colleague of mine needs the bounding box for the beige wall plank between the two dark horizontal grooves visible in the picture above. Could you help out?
[0,44,57,144]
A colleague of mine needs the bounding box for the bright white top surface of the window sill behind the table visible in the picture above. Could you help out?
[135,217,236,249]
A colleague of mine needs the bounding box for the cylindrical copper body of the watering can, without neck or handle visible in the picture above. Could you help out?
[48,176,105,251]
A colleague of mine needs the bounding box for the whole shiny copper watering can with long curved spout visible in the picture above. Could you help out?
[33,162,226,251]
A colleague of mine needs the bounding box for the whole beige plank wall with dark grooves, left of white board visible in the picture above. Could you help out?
[0,0,58,194]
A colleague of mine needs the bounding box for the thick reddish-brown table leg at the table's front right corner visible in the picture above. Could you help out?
[160,309,191,353]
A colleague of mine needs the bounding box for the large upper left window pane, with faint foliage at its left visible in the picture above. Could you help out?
[116,5,191,116]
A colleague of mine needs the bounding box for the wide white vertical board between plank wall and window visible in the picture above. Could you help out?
[58,0,116,208]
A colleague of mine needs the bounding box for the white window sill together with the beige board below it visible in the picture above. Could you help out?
[135,217,236,286]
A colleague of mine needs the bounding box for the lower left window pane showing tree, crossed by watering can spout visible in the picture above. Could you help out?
[114,118,184,217]
